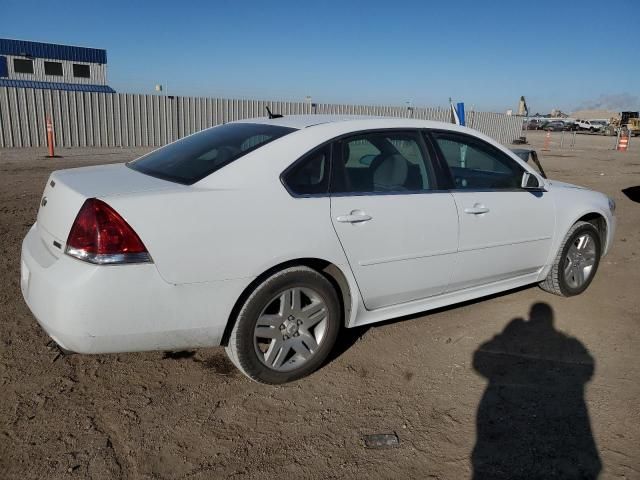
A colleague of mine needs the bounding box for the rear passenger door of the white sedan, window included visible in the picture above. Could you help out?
[331,130,458,309]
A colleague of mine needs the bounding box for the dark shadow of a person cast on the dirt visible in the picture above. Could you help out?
[472,303,602,480]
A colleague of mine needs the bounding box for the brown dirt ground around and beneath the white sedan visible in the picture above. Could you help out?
[0,132,640,479]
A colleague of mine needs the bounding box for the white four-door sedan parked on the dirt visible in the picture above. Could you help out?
[21,115,615,383]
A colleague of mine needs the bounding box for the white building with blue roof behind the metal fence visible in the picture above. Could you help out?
[0,38,115,93]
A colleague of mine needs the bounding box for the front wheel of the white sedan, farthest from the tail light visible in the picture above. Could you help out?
[539,222,602,297]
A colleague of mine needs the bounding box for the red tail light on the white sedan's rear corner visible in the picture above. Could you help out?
[65,198,151,264]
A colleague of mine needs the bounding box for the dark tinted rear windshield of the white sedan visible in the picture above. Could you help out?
[127,123,295,185]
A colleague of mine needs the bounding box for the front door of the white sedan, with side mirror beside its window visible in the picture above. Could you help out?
[431,131,555,291]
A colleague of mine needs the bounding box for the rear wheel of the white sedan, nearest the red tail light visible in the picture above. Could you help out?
[226,266,342,384]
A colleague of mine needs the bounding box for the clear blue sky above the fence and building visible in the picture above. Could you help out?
[0,0,640,113]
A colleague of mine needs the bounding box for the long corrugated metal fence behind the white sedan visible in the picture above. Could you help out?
[0,87,522,147]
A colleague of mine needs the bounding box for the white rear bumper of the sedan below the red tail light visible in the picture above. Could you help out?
[20,226,250,353]
